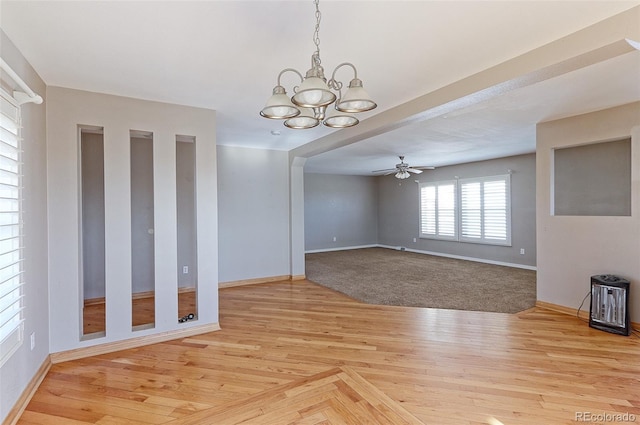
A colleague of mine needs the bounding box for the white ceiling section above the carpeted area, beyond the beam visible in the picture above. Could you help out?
[305,51,640,175]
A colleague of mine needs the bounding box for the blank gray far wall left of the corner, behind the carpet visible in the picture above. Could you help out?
[304,173,378,251]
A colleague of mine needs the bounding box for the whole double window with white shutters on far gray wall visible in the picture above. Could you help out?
[420,174,511,245]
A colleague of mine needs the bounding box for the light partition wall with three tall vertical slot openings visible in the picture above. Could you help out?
[46,86,218,353]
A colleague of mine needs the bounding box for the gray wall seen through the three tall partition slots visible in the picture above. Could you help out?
[82,133,197,299]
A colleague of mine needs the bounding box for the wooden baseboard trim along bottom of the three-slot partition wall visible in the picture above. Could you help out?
[50,323,220,364]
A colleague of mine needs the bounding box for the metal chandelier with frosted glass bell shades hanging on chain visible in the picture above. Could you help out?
[260,0,378,129]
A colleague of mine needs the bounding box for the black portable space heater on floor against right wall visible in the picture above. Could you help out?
[589,274,631,335]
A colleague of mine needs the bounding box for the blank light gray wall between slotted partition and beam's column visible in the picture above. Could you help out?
[217,146,290,282]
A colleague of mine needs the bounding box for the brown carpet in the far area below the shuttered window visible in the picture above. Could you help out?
[306,248,536,313]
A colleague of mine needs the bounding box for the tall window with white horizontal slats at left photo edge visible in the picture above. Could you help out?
[0,90,23,365]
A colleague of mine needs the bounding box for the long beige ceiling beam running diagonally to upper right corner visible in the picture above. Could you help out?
[290,6,640,158]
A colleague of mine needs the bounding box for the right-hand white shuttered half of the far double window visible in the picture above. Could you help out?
[460,174,511,245]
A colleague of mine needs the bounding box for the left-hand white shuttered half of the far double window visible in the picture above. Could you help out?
[420,181,458,240]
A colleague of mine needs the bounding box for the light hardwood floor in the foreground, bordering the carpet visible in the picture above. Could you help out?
[19,281,640,425]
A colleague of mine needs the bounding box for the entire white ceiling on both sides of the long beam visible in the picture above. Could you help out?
[0,0,640,175]
